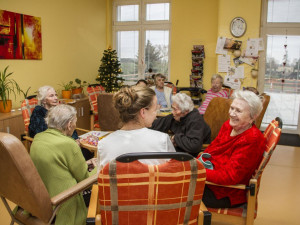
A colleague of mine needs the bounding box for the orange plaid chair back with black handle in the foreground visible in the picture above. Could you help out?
[89,152,211,225]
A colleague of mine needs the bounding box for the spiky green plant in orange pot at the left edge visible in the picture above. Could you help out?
[0,66,20,113]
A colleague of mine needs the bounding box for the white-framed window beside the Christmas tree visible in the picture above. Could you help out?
[113,0,170,85]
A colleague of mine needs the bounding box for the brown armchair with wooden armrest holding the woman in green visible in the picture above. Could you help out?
[0,133,97,225]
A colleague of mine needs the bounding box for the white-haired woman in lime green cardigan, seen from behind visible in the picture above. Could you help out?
[30,104,97,225]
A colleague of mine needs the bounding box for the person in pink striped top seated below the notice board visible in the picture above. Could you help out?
[198,74,228,114]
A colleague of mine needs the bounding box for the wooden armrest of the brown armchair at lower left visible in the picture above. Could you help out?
[51,174,98,206]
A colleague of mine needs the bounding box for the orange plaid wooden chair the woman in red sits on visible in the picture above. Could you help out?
[206,117,282,225]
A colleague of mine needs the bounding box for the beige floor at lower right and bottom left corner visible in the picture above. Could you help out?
[0,146,300,225]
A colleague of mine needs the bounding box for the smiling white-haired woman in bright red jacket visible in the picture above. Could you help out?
[199,91,265,208]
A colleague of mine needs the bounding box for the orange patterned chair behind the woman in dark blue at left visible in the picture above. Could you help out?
[21,96,38,152]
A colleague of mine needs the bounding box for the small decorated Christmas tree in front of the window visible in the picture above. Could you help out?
[96,48,124,92]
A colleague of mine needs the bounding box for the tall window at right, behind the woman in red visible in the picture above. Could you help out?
[258,0,300,133]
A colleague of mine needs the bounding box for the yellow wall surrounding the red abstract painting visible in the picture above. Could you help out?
[0,0,106,107]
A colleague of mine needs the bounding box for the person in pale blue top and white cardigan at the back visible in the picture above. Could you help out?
[151,73,172,108]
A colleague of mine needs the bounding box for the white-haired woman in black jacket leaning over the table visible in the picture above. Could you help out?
[151,93,210,156]
